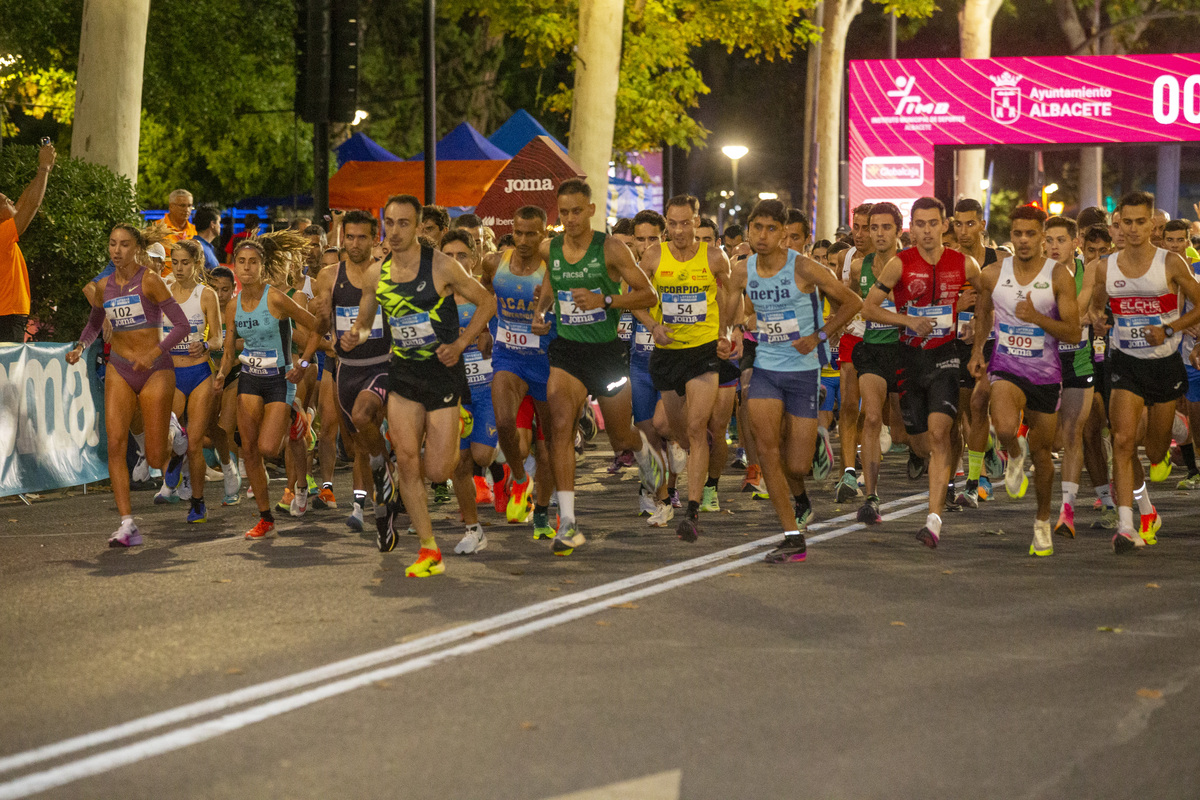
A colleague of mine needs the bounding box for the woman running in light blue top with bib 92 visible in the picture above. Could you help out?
[212,230,316,540]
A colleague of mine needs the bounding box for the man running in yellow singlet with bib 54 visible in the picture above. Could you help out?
[634,194,740,542]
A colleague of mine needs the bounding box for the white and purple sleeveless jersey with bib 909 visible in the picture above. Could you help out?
[988,255,1062,385]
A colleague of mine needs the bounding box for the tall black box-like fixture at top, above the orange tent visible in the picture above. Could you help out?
[295,0,359,122]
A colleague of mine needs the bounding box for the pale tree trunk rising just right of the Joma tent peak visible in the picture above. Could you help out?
[568,0,625,230]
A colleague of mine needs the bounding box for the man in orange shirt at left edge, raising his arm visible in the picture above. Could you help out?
[0,144,56,342]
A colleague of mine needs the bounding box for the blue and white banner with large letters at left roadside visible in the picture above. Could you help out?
[0,342,108,497]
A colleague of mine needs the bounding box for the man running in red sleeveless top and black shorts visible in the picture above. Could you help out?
[863,197,979,548]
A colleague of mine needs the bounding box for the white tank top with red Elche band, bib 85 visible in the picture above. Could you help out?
[1104,247,1183,359]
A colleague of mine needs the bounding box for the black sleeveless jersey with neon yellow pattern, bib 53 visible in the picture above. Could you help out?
[376,245,458,361]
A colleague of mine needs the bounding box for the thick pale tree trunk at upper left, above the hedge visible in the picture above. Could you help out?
[71,0,150,184]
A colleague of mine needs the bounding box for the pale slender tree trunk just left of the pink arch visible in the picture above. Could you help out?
[814,0,863,239]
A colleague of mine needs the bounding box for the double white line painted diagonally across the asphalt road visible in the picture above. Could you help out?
[0,494,926,800]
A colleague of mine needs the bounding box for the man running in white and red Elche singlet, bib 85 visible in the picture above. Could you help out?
[1087,192,1200,553]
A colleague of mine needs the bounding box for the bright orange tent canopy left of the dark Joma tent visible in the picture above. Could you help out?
[329,161,509,209]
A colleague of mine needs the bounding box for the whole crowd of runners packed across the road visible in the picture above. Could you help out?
[49,167,1200,577]
